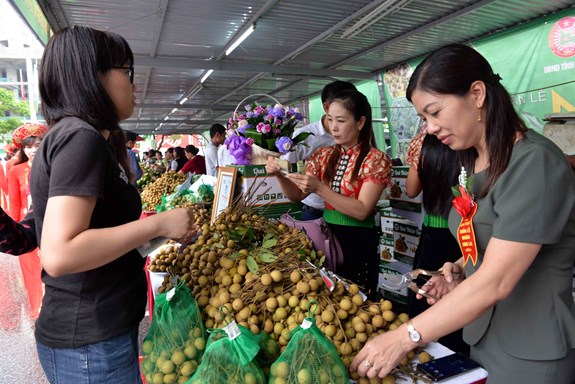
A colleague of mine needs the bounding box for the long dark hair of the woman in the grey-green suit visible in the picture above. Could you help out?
[407,44,527,197]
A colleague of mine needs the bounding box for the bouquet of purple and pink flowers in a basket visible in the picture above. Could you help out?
[225,102,311,165]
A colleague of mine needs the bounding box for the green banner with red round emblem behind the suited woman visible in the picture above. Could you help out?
[383,9,575,160]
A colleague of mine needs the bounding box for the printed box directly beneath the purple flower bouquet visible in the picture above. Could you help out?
[235,164,301,218]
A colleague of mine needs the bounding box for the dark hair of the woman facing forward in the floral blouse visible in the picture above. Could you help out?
[323,89,375,185]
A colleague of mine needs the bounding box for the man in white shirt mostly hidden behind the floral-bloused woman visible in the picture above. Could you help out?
[281,80,356,220]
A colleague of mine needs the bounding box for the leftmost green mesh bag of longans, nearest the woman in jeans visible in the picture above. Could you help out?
[142,281,207,384]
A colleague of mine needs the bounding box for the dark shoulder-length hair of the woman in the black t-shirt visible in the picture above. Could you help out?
[39,26,134,131]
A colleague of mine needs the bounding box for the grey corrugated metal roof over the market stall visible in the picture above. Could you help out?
[39,0,575,134]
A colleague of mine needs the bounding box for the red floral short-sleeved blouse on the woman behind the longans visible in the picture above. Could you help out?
[306,145,391,209]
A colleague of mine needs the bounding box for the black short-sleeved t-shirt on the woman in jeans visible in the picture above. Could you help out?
[30,117,147,348]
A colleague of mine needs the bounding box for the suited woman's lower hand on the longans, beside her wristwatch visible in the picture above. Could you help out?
[349,326,416,379]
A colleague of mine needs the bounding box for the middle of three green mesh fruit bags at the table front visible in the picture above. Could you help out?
[186,309,267,384]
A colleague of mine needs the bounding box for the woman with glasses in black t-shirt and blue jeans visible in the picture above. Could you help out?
[31,26,198,384]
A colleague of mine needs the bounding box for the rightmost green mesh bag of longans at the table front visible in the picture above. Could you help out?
[269,300,349,384]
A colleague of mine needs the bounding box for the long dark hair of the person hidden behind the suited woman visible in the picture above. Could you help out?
[417,135,459,217]
